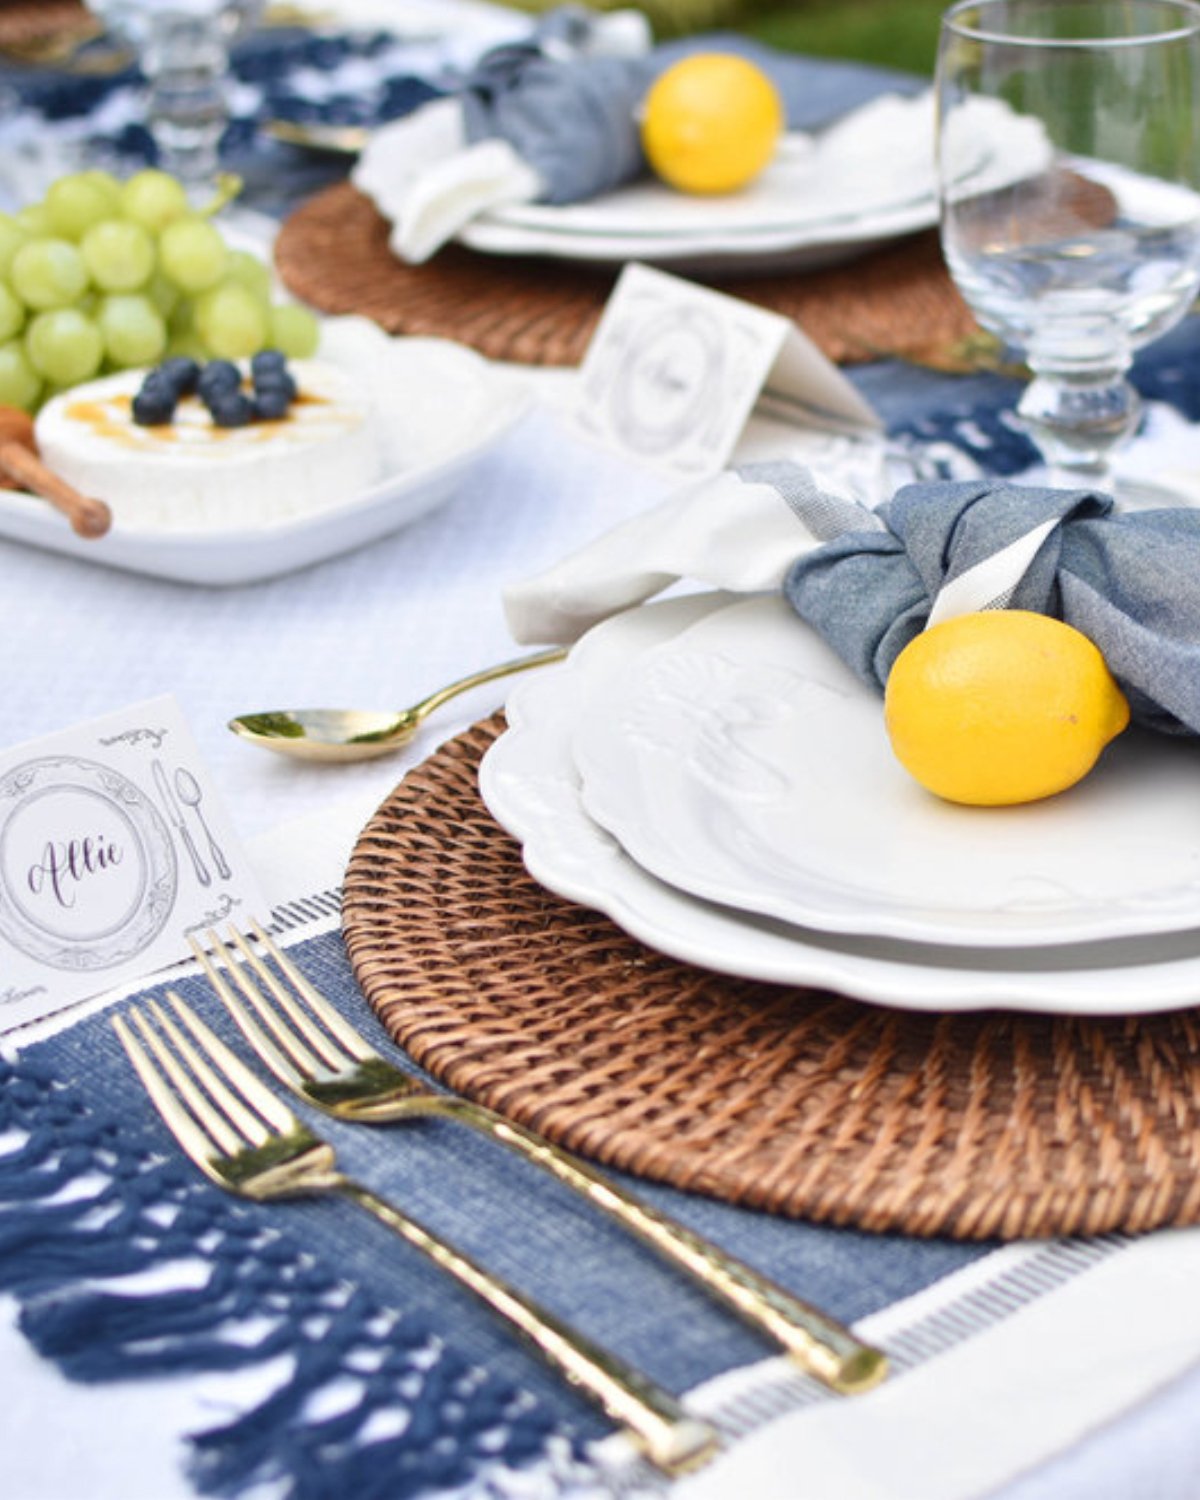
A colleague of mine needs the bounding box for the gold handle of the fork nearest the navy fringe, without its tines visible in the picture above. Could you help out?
[335,1178,717,1475]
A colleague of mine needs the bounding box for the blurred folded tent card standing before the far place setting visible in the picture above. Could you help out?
[573,263,882,477]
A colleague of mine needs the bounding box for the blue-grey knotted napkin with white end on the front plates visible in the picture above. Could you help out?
[504,462,1200,734]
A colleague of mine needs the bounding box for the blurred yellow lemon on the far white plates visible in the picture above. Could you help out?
[642,53,783,194]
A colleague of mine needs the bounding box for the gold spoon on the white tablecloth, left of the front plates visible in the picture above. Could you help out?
[230,648,567,762]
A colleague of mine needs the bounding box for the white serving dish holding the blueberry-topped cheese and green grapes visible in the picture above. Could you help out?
[0,318,531,585]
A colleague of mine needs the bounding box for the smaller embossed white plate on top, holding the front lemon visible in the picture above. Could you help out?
[573,596,1200,948]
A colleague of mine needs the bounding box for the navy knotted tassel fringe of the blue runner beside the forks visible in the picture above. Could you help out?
[0,1026,573,1500]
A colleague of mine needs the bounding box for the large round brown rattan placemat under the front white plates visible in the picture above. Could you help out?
[344,716,1200,1239]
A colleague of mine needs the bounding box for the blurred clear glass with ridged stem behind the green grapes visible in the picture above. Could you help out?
[89,0,263,192]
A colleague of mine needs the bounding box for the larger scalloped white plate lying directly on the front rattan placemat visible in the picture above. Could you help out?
[480,594,1200,1016]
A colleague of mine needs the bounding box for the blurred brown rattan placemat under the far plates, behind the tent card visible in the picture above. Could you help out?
[276,183,978,365]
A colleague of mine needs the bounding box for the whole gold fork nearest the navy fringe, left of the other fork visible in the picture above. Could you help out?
[113,990,717,1475]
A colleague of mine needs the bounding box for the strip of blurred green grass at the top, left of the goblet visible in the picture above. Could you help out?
[510,0,948,75]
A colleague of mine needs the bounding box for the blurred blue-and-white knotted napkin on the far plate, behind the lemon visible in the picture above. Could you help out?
[351,6,923,263]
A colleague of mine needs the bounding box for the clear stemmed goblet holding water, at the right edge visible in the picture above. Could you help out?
[938,0,1200,489]
